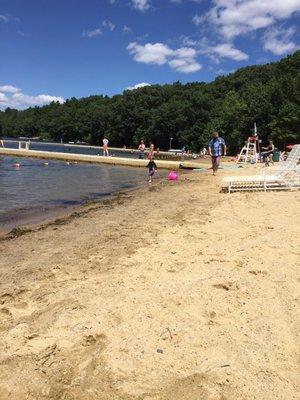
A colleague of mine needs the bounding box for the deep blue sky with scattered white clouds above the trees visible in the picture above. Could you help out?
[0,0,300,109]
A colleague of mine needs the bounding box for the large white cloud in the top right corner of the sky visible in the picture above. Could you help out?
[205,0,300,39]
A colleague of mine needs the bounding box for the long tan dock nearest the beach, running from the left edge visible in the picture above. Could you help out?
[0,147,207,170]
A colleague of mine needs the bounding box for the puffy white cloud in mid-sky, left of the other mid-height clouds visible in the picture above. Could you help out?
[127,42,202,73]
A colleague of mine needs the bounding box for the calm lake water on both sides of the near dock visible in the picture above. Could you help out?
[0,142,147,232]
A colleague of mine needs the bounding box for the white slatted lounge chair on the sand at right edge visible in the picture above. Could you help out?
[222,145,300,193]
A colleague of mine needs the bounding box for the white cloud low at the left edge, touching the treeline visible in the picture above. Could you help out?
[0,85,65,109]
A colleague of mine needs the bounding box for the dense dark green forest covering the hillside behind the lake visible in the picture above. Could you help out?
[0,51,300,153]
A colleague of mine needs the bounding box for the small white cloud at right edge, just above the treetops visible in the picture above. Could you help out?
[262,28,298,56]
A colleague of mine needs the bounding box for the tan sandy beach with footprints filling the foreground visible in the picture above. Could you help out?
[0,173,300,400]
